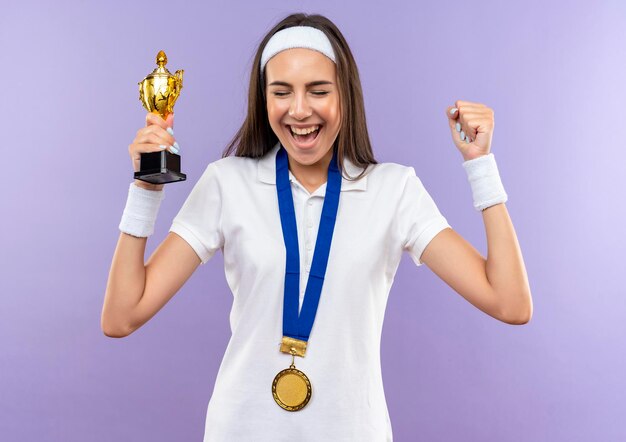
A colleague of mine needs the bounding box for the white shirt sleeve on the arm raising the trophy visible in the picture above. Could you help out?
[170,163,224,264]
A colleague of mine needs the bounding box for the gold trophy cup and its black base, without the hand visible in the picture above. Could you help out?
[135,51,187,184]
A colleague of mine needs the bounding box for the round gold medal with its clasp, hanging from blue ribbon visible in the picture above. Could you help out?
[272,336,312,411]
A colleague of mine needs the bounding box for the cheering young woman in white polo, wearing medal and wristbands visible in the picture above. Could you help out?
[102,14,532,442]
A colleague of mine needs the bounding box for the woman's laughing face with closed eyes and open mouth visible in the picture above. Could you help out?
[264,48,341,173]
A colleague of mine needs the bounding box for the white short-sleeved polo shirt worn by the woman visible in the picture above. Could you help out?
[170,143,450,442]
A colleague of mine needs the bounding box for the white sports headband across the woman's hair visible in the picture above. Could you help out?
[261,26,337,78]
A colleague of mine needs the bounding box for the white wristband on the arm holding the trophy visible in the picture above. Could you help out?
[119,182,165,238]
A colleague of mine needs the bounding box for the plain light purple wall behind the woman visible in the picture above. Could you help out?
[0,0,626,442]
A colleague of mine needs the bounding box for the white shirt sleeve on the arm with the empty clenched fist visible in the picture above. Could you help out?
[396,167,450,266]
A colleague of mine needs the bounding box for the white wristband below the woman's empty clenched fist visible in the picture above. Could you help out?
[463,153,508,211]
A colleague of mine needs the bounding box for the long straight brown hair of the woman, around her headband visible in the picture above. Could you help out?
[222,13,378,179]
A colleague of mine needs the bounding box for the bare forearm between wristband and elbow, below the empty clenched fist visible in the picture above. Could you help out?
[482,203,533,323]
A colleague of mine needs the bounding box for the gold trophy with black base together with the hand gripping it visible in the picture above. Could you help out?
[129,51,187,189]
